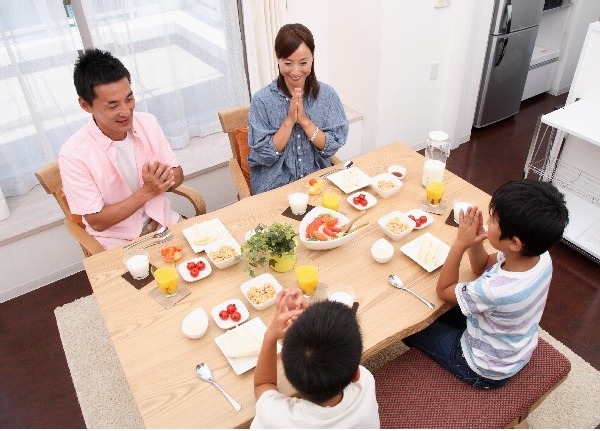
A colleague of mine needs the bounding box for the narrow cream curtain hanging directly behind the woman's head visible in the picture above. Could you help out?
[242,0,284,94]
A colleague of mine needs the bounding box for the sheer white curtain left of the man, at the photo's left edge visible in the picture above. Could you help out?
[0,0,85,196]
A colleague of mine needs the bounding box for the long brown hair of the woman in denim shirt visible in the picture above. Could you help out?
[275,24,319,99]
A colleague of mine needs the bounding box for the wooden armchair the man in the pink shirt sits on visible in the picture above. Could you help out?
[35,161,206,257]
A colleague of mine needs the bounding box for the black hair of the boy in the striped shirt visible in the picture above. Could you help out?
[490,179,569,256]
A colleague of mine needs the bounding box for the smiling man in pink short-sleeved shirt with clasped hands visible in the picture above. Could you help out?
[58,49,183,248]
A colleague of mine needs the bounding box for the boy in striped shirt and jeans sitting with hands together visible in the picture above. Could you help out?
[404,180,569,389]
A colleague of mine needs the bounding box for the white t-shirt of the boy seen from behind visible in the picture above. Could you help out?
[250,365,380,429]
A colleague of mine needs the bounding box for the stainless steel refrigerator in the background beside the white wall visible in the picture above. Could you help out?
[473,0,544,127]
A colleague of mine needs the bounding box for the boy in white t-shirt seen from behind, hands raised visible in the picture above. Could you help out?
[250,289,380,429]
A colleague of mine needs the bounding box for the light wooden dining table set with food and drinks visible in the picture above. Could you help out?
[84,143,492,428]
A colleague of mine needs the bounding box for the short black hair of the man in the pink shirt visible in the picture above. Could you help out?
[73,48,131,105]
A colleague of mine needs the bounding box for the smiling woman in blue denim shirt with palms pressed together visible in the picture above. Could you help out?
[248,24,348,194]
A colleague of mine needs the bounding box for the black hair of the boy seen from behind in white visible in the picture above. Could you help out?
[281,301,362,404]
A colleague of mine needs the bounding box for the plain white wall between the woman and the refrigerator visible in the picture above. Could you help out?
[283,0,493,151]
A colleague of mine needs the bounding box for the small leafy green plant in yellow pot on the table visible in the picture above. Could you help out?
[242,222,297,277]
